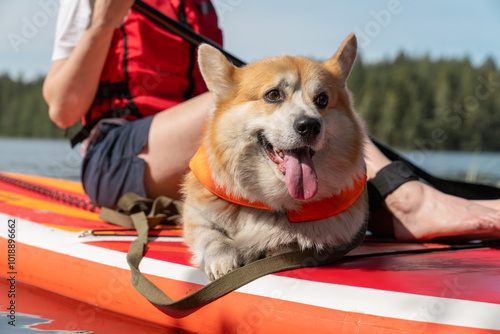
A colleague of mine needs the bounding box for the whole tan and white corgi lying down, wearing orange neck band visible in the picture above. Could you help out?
[182,34,367,280]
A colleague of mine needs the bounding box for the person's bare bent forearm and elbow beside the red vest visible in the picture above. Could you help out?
[43,0,133,128]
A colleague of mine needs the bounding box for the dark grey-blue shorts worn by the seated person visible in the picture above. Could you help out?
[82,116,153,209]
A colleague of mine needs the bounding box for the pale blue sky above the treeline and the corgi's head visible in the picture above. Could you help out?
[0,0,500,79]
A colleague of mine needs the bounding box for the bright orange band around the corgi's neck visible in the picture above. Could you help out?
[189,146,366,223]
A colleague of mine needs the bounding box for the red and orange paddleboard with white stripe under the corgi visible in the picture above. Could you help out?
[0,173,500,334]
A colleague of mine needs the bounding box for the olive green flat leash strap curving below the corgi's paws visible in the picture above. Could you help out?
[103,193,367,309]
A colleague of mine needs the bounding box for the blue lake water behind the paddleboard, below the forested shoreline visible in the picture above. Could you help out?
[0,137,500,185]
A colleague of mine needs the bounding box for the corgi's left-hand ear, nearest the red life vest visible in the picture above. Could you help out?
[198,44,236,102]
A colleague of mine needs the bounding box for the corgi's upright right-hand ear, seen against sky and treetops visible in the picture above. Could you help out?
[323,34,358,86]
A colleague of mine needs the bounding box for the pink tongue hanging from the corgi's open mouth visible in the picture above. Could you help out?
[283,148,318,201]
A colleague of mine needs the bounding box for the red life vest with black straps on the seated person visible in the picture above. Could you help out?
[73,0,222,144]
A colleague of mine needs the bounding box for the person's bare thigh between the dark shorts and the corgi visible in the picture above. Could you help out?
[139,93,212,199]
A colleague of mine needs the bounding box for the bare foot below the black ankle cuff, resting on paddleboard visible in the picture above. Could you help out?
[385,181,500,240]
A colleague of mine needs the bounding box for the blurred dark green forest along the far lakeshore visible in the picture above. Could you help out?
[0,53,500,151]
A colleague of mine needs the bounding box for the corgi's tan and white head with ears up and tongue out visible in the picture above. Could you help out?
[199,35,363,207]
